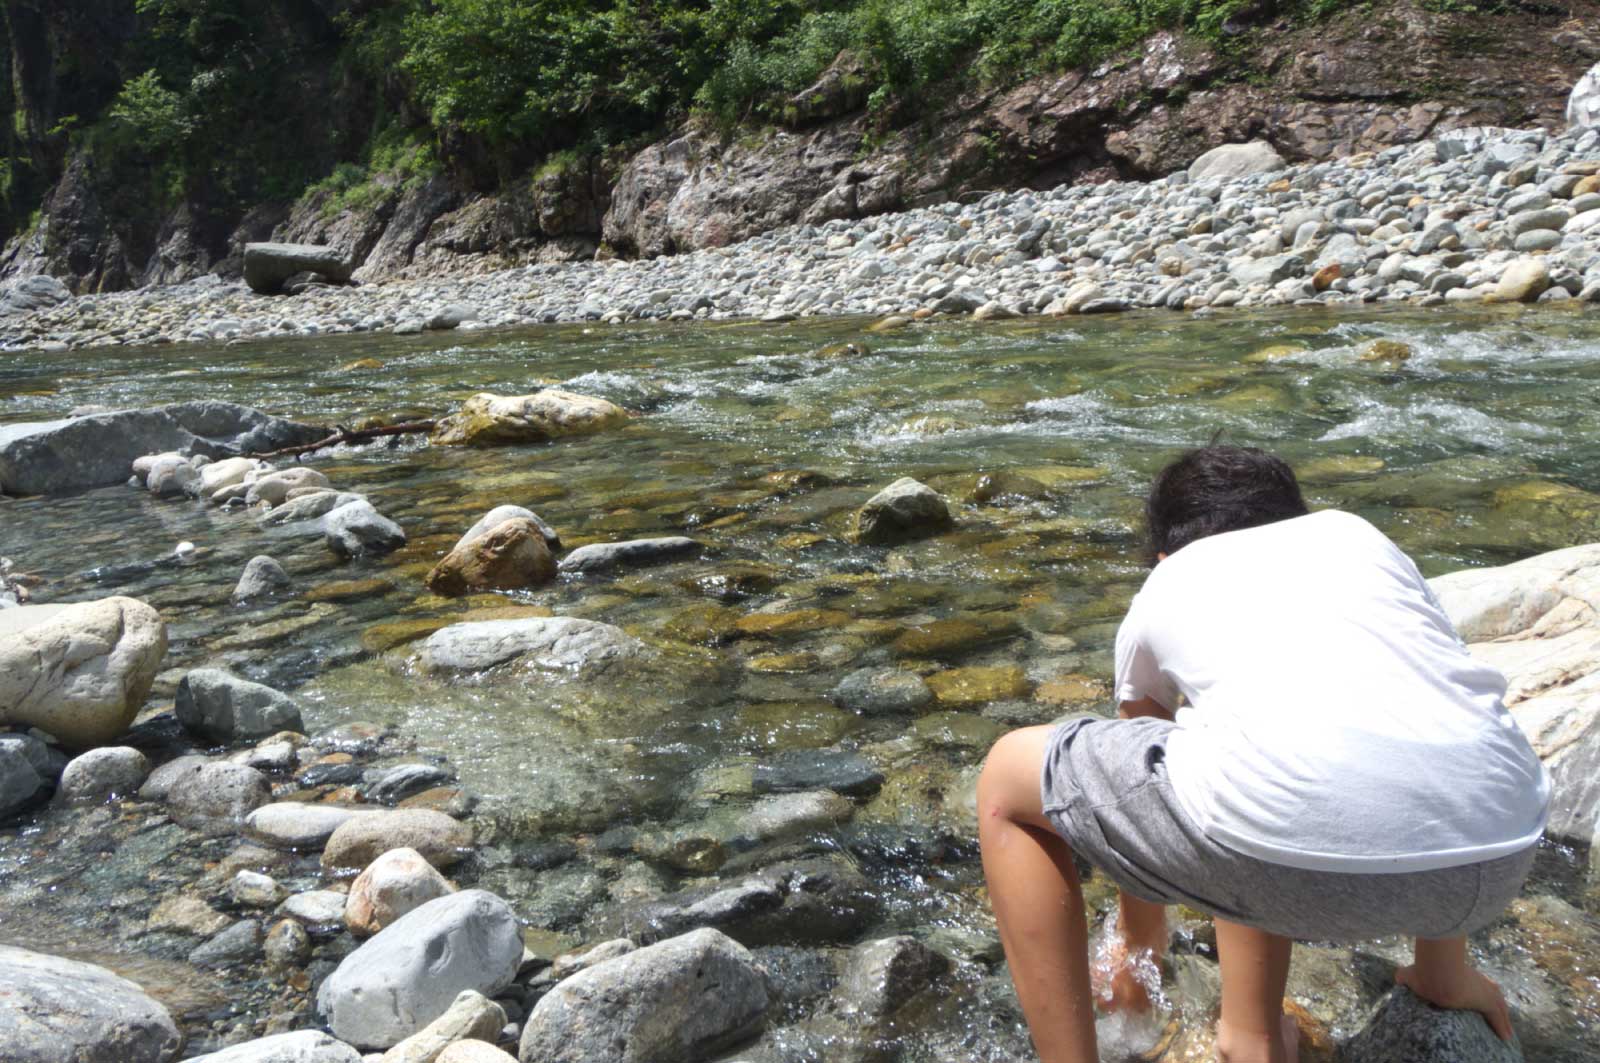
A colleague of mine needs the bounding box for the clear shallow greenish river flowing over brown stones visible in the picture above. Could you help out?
[0,307,1600,1060]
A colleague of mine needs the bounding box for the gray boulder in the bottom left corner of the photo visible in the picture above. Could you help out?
[0,945,184,1063]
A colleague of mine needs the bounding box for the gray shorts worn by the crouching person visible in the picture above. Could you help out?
[1042,717,1534,941]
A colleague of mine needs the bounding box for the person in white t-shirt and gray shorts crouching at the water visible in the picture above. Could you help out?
[978,447,1549,1063]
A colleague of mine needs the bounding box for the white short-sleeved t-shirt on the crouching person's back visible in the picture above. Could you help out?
[1117,511,1550,872]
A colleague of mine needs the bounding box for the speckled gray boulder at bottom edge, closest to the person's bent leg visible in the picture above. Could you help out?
[518,930,773,1063]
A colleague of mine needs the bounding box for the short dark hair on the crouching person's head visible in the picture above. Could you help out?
[1144,443,1307,562]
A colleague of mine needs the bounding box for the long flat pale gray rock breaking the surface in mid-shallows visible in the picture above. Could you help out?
[422,616,645,677]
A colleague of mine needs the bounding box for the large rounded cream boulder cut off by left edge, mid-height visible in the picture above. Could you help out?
[0,597,166,748]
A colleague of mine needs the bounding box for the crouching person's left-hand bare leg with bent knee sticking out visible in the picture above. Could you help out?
[978,727,1099,1063]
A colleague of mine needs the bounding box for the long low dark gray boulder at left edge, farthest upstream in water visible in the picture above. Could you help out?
[0,400,328,495]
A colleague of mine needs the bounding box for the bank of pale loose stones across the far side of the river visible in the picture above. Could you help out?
[0,120,1600,351]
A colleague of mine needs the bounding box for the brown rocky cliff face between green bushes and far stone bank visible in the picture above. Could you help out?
[0,0,1600,291]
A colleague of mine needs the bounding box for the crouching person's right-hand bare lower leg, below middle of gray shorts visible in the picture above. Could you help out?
[1216,919,1299,1063]
